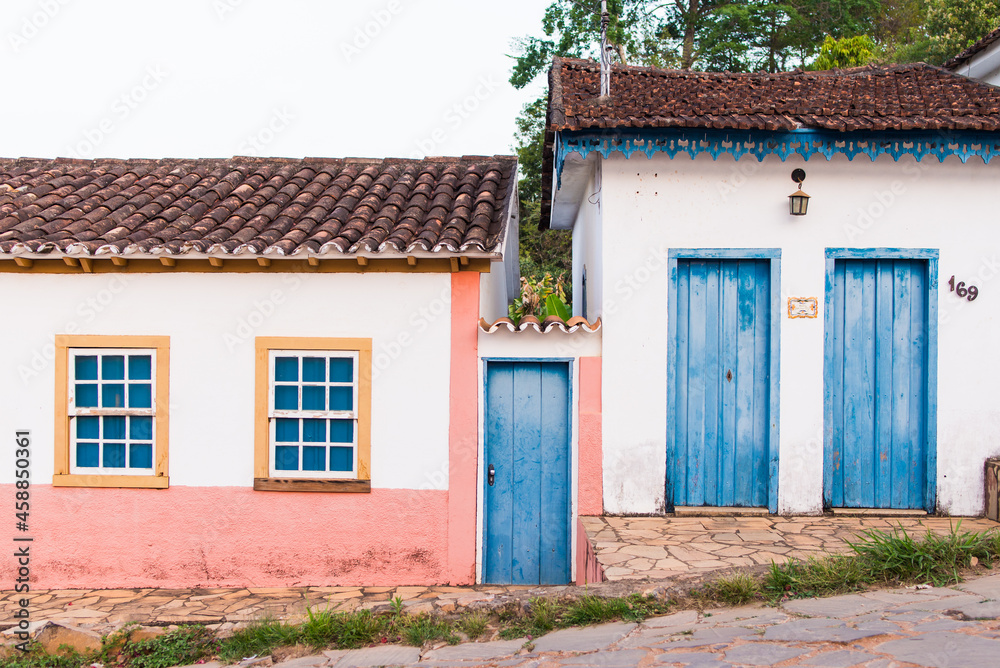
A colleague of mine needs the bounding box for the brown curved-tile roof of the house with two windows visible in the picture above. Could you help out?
[0,156,517,255]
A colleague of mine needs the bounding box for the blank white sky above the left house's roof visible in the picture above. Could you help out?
[0,0,550,158]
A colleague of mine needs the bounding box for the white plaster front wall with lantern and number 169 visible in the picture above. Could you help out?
[595,154,1000,515]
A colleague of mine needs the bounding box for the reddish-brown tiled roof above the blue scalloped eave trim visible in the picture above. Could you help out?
[548,58,1000,131]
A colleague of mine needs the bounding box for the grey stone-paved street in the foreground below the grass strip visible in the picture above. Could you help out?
[172,575,1000,668]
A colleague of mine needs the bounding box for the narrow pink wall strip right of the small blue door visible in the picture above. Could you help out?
[577,357,604,515]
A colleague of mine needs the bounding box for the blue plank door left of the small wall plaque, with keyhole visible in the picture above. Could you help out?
[667,259,772,507]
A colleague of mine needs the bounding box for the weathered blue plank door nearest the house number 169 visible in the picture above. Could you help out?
[824,259,930,509]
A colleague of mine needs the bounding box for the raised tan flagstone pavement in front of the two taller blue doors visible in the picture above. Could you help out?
[580,515,1000,580]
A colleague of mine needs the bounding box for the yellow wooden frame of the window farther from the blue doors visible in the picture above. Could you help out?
[52,334,170,489]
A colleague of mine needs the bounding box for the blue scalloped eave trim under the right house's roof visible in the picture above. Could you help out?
[555,129,1000,187]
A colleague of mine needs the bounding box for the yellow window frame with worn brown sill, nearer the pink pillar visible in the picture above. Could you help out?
[253,337,372,493]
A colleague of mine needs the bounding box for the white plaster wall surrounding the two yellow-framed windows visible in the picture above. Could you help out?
[0,273,451,489]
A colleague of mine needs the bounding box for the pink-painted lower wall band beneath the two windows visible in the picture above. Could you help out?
[0,485,448,589]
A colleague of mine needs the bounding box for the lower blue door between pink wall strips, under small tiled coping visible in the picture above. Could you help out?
[483,361,571,584]
